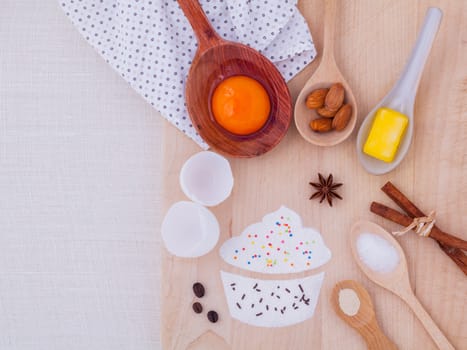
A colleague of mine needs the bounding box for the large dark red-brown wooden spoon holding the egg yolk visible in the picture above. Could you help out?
[178,0,292,157]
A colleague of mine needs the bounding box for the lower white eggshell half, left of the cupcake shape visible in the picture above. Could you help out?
[161,201,219,258]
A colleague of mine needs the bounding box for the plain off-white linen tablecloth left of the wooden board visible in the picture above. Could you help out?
[0,0,163,350]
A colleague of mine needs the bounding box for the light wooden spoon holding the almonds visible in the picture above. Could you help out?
[294,0,357,146]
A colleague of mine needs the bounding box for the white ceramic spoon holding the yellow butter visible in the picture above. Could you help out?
[357,7,443,175]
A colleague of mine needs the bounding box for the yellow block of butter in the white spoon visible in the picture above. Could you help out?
[363,107,409,163]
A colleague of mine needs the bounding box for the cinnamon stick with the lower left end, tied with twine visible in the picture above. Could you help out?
[370,202,467,250]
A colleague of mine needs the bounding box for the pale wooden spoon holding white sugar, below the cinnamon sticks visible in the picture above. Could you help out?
[350,221,454,350]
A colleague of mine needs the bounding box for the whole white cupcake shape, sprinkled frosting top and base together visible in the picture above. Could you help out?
[220,206,331,327]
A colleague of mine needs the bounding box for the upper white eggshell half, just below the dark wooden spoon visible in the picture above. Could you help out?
[180,151,233,207]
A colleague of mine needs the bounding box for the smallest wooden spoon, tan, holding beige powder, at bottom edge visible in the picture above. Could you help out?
[331,280,397,350]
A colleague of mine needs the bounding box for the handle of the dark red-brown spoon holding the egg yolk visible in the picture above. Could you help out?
[178,0,222,54]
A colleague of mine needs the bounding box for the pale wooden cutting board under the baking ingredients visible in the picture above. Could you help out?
[161,0,467,350]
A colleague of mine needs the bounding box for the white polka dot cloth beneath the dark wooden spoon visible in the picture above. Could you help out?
[60,0,316,149]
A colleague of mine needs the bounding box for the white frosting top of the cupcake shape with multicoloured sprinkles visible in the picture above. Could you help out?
[220,206,331,274]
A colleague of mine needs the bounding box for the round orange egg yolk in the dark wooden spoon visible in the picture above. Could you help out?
[211,75,271,135]
